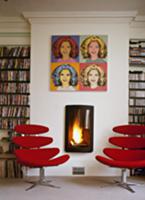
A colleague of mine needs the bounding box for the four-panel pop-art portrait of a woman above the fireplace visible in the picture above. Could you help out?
[50,35,108,91]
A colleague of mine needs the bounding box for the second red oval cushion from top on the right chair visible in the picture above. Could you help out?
[109,136,145,149]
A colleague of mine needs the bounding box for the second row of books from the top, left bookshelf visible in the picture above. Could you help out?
[0,58,30,70]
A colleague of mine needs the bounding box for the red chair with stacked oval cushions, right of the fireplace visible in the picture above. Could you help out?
[96,125,145,192]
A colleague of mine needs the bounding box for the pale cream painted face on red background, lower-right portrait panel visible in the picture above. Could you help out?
[88,69,99,86]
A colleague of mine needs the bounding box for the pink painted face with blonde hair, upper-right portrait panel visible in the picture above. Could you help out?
[88,41,99,58]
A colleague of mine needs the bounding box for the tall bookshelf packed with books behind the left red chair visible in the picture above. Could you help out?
[0,45,30,178]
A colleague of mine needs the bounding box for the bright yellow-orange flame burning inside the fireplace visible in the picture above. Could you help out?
[71,121,83,144]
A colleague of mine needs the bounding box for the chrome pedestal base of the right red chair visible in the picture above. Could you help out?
[115,169,135,193]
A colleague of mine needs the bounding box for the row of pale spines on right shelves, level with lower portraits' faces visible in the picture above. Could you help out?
[129,71,145,81]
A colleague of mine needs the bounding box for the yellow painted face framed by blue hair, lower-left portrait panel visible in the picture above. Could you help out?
[60,69,71,85]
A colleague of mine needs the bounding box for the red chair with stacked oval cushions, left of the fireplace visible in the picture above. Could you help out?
[13,124,69,190]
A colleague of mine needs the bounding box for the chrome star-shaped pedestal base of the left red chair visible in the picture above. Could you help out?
[26,167,60,191]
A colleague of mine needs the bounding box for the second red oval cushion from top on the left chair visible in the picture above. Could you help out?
[12,136,53,148]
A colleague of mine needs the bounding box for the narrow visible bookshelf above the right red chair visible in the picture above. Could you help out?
[129,39,145,124]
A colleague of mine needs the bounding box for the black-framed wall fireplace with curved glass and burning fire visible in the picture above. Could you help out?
[65,105,94,152]
